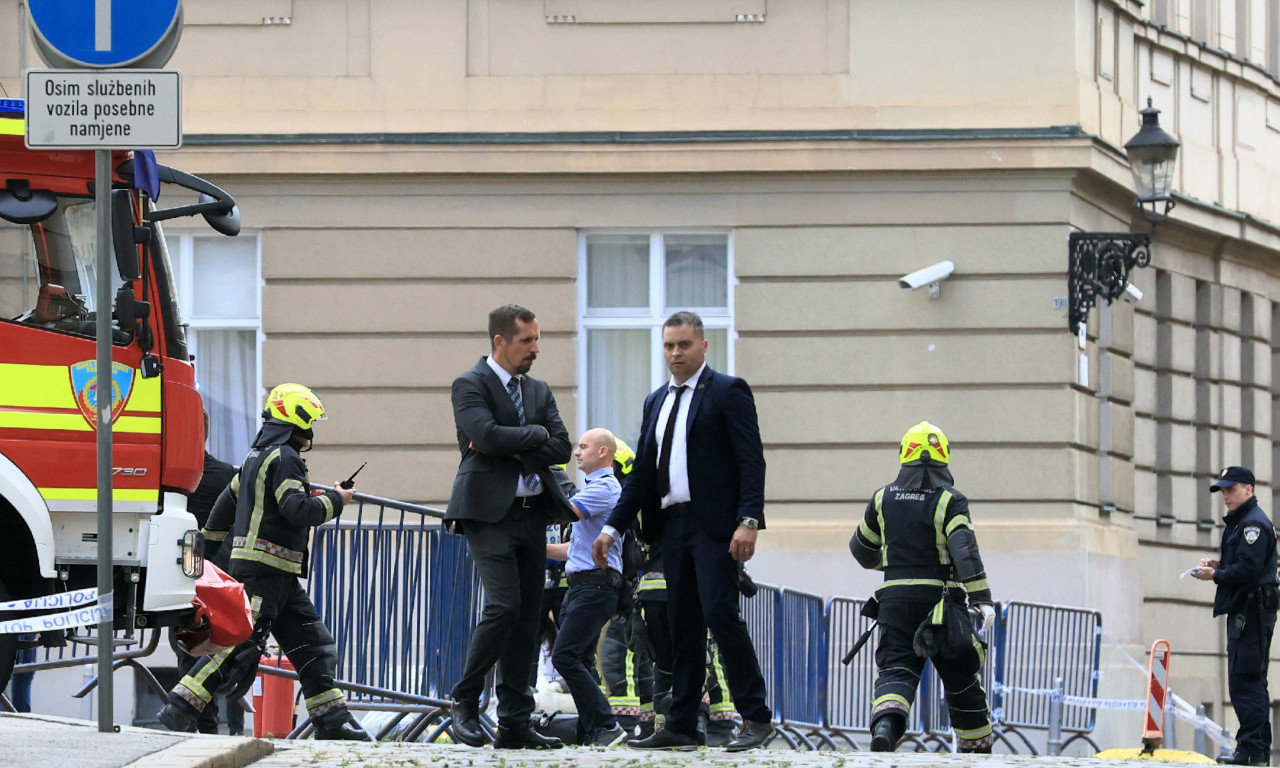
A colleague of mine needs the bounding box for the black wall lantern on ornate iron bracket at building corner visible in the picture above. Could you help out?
[1066,99,1181,333]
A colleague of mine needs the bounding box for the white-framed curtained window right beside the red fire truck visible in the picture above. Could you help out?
[165,233,262,465]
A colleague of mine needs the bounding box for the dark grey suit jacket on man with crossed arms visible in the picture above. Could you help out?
[444,357,577,522]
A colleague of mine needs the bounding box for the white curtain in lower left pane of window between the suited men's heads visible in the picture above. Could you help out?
[586,329,653,449]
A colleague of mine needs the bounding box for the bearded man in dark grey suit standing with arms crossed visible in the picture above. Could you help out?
[444,305,576,749]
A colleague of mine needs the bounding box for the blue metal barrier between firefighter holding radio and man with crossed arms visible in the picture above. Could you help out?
[310,495,481,699]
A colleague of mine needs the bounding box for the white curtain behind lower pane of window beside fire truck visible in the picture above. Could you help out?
[192,329,261,465]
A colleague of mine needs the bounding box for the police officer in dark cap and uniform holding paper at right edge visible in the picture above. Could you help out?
[1192,467,1280,765]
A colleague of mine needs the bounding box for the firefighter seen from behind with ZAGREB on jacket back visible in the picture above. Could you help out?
[849,421,996,753]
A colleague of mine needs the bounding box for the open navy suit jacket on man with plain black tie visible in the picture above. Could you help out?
[609,367,764,543]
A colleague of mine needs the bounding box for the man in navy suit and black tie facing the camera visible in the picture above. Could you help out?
[593,312,774,751]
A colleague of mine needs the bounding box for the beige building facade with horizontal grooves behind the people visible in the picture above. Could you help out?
[0,0,1280,742]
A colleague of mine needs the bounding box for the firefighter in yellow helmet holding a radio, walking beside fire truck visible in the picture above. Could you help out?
[159,384,369,741]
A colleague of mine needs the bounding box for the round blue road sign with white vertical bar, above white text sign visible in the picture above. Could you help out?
[27,0,182,67]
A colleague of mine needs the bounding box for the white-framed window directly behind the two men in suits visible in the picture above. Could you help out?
[577,232,733,448]
